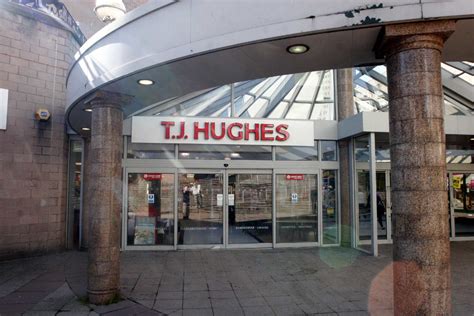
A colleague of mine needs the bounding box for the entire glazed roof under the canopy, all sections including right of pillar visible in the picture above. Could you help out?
[130,62,474,120]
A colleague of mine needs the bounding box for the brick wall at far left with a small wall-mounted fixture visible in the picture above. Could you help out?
[0,9,78,259]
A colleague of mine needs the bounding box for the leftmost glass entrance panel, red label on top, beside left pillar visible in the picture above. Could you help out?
[127,173,174,245]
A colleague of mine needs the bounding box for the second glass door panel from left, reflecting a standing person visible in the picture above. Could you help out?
[178,173,223,245]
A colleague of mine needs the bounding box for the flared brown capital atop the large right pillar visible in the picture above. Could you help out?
[374,20,456,58]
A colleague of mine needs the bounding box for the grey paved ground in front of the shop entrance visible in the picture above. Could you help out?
[0,242,474,316]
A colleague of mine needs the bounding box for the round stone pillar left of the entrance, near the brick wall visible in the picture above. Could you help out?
[87,92,124,304]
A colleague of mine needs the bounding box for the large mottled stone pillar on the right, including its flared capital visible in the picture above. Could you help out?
[379,21,455,315]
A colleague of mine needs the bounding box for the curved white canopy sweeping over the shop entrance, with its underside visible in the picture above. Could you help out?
[67,0,474,130]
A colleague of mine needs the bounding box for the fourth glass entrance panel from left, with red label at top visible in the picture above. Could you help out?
[276,174,318,243]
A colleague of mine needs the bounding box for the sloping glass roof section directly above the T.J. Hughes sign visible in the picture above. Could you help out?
[132,70,335,120]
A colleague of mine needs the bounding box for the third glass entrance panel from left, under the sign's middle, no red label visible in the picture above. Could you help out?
[228,174,272,244]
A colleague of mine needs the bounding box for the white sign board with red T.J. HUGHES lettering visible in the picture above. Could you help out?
[132,116,314,147]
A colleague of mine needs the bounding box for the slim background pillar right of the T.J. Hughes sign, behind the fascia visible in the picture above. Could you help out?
[336,68,354,247]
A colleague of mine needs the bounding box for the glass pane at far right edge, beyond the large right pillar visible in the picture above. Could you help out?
[451,173,474,237]
